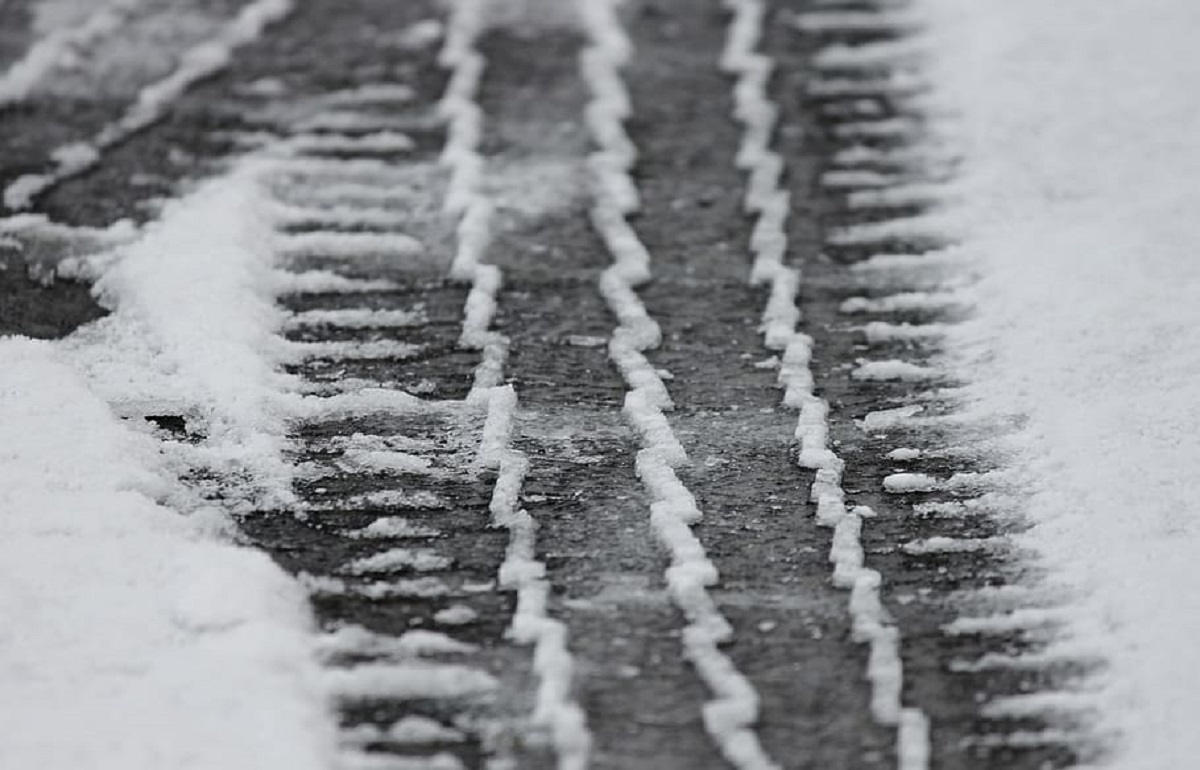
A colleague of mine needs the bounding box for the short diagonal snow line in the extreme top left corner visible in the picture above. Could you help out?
[0,0,144,108]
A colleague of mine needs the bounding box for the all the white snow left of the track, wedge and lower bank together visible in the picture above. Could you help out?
[0,161,336,770]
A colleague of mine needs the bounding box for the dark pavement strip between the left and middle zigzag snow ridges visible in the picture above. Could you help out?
[480,13,720,769]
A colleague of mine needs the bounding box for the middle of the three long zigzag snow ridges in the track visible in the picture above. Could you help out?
[577,0,779,770]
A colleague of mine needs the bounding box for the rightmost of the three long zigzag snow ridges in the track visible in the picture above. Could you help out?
[721,0,929,770]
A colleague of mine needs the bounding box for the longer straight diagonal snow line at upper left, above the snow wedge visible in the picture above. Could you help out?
[4,0,293,210]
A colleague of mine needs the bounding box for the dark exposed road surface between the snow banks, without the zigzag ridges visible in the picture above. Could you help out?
[0,0,1087,770]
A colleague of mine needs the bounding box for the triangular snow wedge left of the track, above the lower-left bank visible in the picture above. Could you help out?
[64,161,293,504]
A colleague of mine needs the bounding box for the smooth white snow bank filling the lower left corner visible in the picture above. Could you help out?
[0,338,334,770]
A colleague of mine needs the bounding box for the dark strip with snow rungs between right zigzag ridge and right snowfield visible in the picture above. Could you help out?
[772,2,1094,768]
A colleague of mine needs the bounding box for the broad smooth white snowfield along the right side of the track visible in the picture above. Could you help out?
[917,0,1200,770]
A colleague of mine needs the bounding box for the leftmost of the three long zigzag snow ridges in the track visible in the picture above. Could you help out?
[438,0,592,770]
